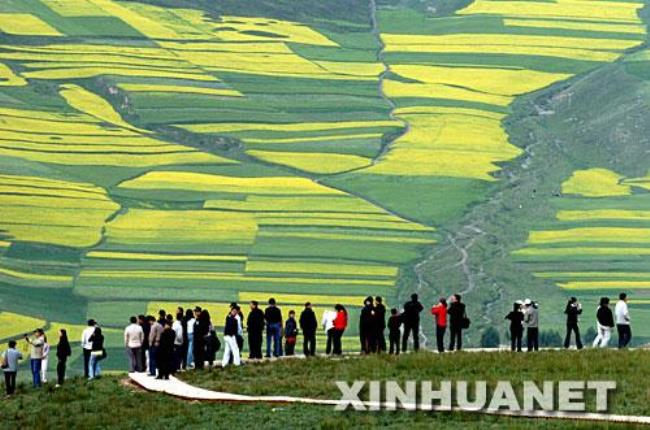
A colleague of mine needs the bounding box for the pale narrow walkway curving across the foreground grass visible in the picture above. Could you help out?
[129,373,650,425]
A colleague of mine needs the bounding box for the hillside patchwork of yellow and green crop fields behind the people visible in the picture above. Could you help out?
[0,0,650,374]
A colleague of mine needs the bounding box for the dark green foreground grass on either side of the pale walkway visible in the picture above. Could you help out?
[2,351,650,429]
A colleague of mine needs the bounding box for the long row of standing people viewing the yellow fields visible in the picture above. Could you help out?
[1,293,632,395]
